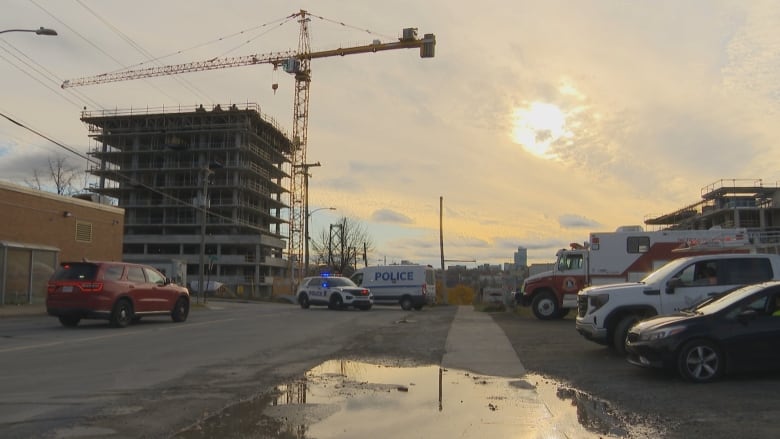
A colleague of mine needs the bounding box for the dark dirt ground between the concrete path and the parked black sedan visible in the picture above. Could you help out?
[491,309,780,439]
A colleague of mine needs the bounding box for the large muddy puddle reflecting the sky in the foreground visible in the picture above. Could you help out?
[175,360,662,439]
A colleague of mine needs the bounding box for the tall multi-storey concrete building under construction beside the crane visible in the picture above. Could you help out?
[81,104,293,297]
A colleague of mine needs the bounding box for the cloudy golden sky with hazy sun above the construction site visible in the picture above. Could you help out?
[0,0,780,267]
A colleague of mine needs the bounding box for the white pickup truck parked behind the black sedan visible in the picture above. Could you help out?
[576,253,780,353]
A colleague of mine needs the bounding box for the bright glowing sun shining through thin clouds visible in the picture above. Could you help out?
[512,102,566,158]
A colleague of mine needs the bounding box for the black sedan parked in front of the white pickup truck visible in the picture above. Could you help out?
[625,281,780,383]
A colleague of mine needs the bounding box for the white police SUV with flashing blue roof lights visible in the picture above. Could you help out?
[295,276,374,310]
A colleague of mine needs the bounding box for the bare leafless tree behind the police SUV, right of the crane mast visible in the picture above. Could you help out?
[312,217,374,276]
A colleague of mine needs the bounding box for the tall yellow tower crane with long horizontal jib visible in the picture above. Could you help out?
[62,9,436,286]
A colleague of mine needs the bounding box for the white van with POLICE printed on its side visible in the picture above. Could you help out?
[350,265,436,311]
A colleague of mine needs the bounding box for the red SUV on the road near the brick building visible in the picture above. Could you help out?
[46,261,190,328]
